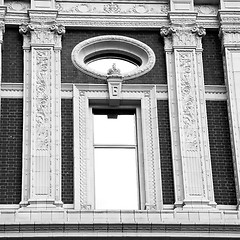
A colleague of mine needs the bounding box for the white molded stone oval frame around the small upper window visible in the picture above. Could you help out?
[72,35,156,80]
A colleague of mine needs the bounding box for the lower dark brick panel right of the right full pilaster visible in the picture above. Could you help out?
[207,101,237,205]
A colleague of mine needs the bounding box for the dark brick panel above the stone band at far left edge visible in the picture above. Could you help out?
[2,27,23,83]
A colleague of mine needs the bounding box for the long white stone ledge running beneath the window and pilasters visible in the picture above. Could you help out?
[0,209,240,239]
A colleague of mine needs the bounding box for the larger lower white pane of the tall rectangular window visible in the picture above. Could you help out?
[94,148,139,210]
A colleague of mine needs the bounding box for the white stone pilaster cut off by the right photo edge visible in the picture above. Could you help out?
[219,10,240,207]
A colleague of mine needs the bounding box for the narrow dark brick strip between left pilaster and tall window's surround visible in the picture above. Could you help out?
[62,99,74,204]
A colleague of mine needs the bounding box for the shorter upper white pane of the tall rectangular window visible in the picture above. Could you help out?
[94,115,136,145]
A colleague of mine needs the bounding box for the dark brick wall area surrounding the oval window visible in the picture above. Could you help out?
[62,29,167,84]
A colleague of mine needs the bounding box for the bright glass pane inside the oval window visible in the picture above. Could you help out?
[88,58,137,74]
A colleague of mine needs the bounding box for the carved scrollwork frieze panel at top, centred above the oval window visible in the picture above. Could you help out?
[56,2,169,15]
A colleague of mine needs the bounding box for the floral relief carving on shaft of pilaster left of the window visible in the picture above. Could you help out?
[36,50,50,149]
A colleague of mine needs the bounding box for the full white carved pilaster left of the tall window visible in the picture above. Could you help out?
[20,10,65,207]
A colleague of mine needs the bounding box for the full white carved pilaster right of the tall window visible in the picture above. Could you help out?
[161,12,215,208]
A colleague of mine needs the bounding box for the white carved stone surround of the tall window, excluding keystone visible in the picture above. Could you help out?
[73,84,162,210]
